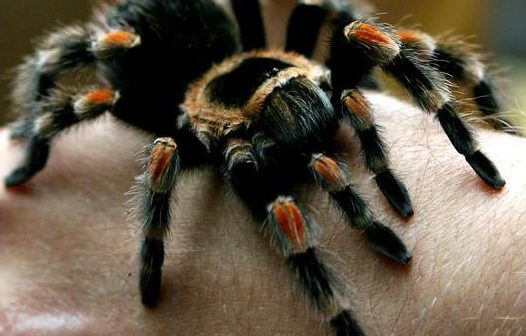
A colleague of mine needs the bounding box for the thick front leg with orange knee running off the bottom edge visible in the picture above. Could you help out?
[224,137,364,335]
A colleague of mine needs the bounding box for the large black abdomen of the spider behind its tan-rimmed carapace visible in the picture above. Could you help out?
[99,0,241,135]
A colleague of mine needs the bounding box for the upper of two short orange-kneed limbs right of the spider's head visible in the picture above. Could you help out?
[341,89,413,218]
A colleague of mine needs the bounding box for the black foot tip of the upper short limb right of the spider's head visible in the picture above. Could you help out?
[375,170,414,218]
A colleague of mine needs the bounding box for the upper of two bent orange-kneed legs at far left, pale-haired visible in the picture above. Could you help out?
[11,26,140,139]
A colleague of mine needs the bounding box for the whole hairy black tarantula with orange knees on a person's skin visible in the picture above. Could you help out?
[5,0,505,335]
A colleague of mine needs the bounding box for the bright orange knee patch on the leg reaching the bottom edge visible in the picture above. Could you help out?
[272,196,305,246]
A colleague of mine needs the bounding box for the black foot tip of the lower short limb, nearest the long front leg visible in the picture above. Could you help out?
[364,222,412,265]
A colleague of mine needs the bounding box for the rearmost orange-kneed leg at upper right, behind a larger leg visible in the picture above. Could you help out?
[397,29,516,133]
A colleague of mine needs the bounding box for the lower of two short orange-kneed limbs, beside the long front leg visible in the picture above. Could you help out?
[310,154,411,264]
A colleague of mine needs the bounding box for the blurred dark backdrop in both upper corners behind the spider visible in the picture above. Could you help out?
[0,0,526,125]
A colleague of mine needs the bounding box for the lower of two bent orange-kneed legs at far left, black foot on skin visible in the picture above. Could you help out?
[5,89,119,187]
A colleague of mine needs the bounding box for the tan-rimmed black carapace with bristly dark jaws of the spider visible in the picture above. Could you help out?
[182,51,337,148]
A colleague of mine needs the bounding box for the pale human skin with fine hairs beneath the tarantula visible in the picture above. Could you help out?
[0,94,526,335]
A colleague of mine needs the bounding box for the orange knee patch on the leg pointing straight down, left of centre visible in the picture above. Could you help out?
[148,138,177,189]
